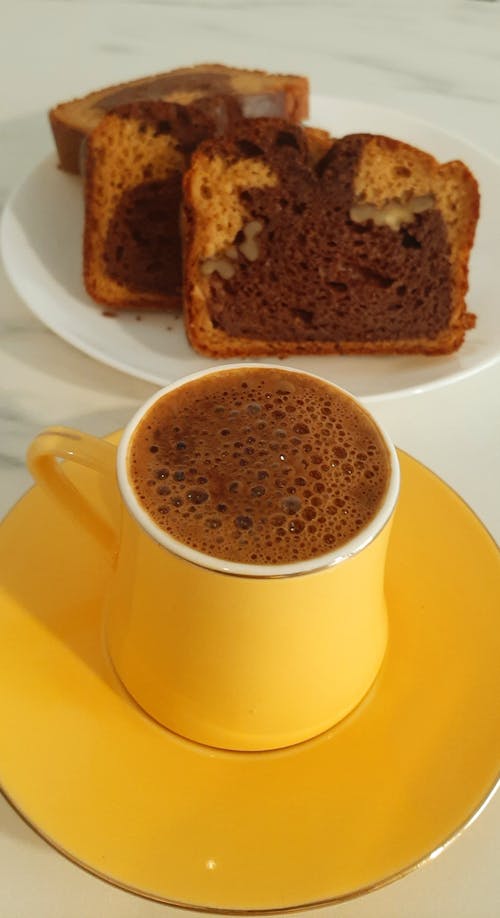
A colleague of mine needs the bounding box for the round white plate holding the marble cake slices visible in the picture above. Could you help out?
[1,96,500,400]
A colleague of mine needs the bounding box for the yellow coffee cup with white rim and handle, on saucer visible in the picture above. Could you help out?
[28,364,399,750]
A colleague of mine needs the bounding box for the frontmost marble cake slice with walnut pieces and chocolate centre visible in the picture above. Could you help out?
[183,119,479,357]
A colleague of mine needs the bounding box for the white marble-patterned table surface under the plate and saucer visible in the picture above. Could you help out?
[0,0,500,918]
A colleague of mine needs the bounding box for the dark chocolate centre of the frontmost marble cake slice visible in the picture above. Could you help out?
[201,130,452,342]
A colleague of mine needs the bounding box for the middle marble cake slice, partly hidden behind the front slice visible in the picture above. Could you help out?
[83,96,248,310]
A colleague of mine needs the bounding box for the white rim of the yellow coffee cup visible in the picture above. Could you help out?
[117,363,400,578]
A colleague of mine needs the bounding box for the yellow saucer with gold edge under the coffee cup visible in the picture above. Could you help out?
[0,444,500,911]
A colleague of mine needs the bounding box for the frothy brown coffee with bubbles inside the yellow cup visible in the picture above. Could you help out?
[128,367,390,564]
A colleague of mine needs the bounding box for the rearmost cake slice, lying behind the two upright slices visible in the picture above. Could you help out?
[49,64,309,173]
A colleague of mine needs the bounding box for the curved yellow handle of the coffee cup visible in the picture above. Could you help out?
[26,427,117,551]
